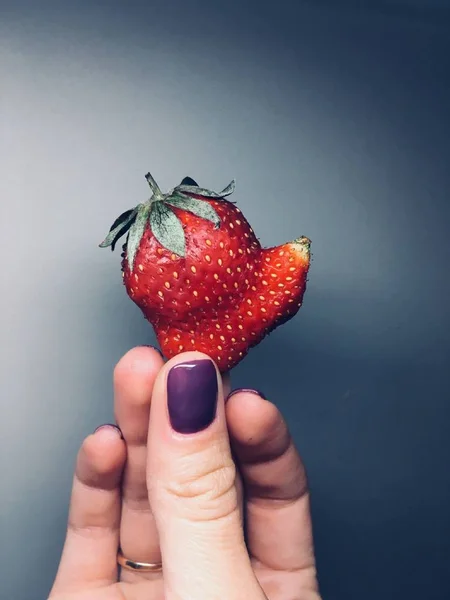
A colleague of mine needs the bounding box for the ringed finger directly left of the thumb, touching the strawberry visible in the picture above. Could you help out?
[114,347,163,580]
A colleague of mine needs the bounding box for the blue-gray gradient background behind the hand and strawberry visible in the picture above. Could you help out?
[0,0,450,600]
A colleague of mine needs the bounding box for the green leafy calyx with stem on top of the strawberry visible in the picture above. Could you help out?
[100,173,235,272]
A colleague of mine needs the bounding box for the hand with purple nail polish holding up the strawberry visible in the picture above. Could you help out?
[50,347,320,600]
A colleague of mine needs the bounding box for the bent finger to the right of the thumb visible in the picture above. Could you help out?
[226,390,317,597]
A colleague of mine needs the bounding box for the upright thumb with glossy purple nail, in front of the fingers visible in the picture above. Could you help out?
[147,352,265,600]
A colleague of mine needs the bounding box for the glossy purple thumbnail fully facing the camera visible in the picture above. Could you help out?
[167,360,218,433]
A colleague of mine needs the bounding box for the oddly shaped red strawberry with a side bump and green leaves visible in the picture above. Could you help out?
[100,173,311,372]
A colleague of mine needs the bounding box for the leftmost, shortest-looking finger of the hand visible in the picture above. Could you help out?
[49,425,126,598]
